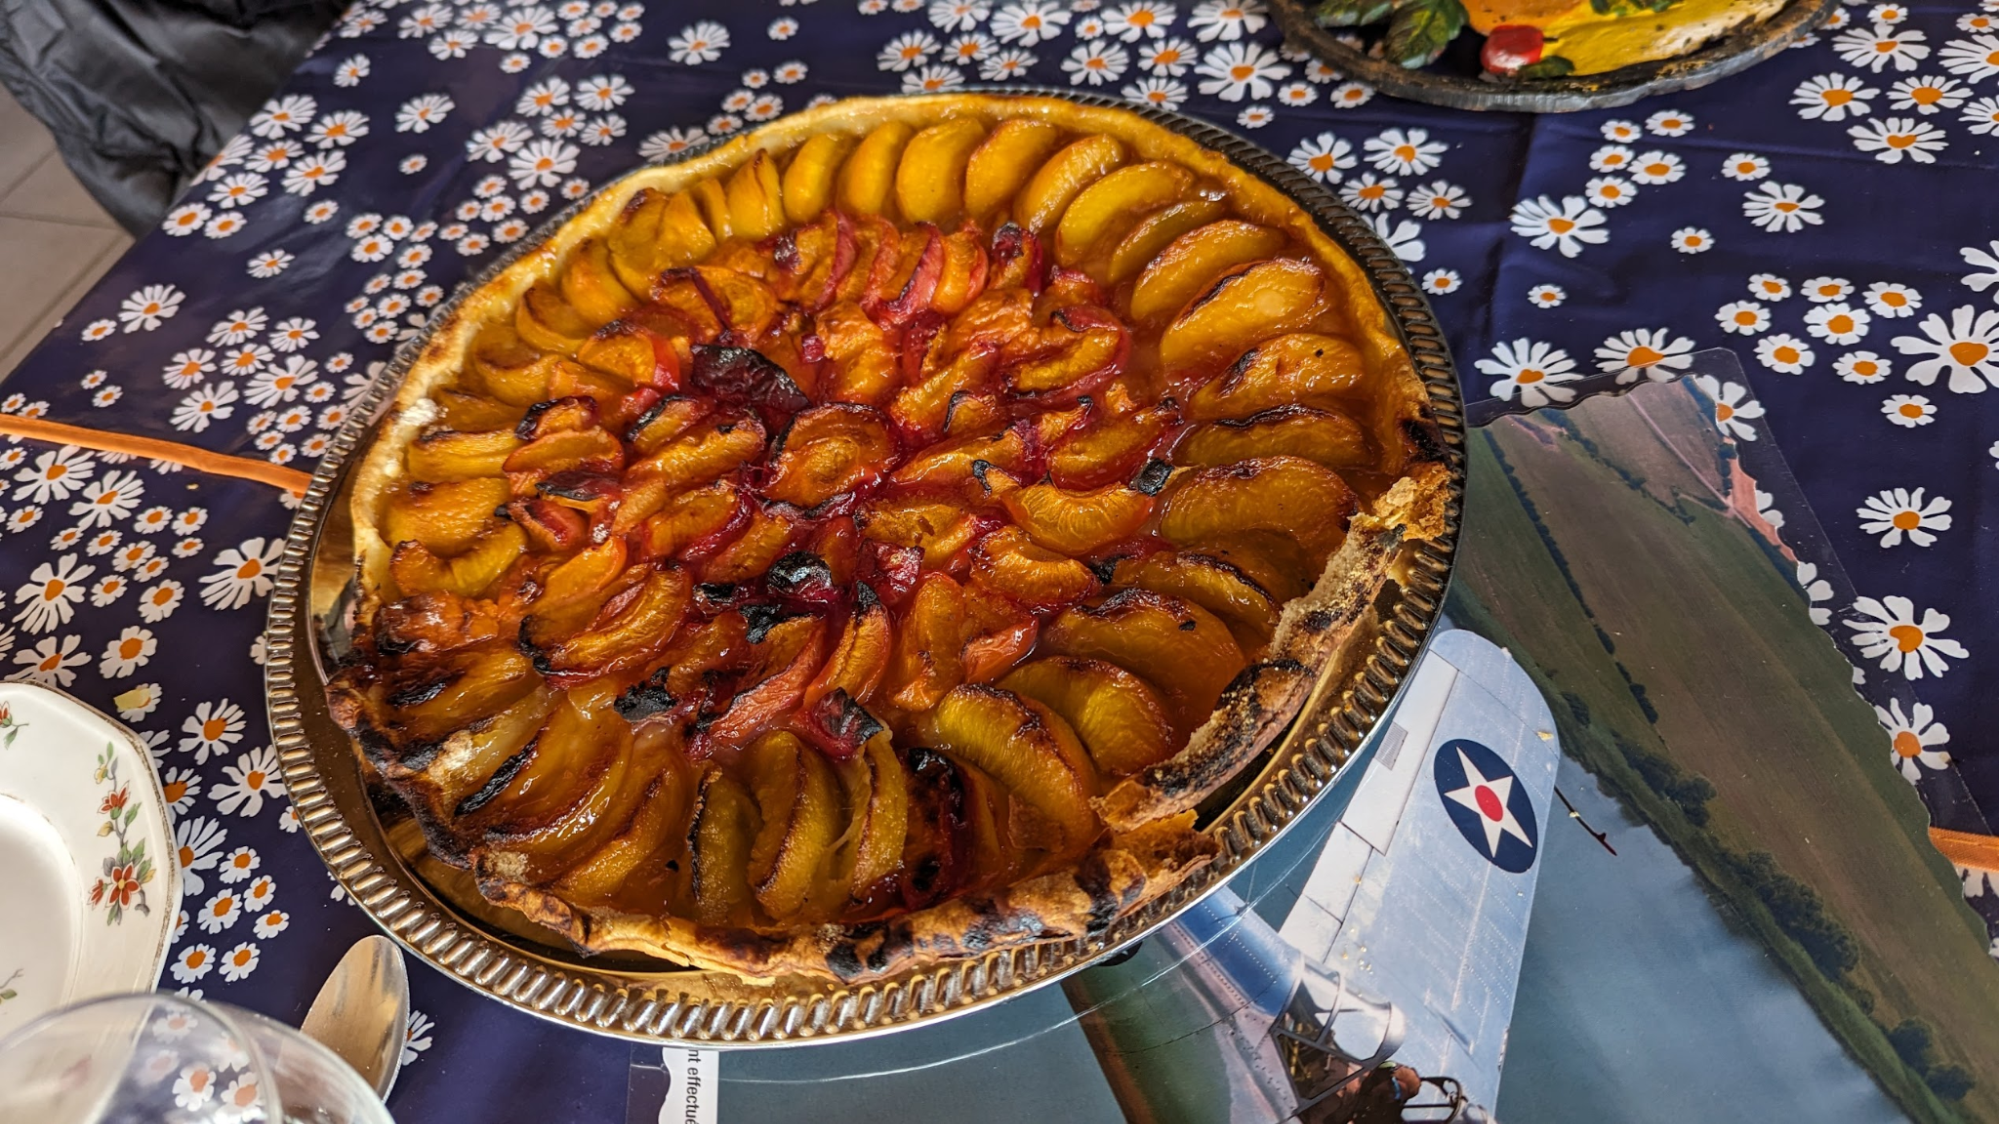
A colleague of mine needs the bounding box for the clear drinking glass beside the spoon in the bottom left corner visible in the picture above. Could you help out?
[0,993,392,1123]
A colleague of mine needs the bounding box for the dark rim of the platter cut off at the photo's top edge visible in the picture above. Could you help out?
[1271,0,1841,114]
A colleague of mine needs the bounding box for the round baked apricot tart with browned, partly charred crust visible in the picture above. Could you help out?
[330,96,1449,981]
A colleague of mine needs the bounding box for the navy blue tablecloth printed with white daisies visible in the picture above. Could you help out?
[0,0,1999,1119]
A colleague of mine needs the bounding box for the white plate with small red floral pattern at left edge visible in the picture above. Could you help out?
[0,683,180,1035]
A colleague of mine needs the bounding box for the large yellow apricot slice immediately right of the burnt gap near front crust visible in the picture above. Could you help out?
[922,683,1101,851]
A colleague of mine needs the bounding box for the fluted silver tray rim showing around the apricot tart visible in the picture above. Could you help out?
[266,90,1463,1047]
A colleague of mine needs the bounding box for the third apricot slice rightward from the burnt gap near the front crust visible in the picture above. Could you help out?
[1041,589,1243,731]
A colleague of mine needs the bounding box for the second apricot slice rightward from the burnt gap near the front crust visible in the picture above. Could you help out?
[1000,655,1179,777]
